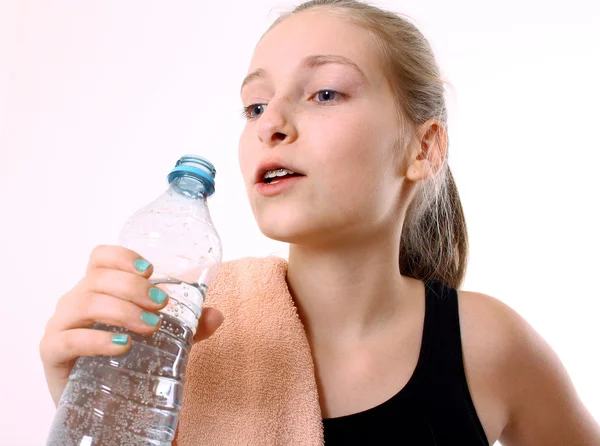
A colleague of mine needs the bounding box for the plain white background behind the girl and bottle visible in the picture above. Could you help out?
[0,0,600,446]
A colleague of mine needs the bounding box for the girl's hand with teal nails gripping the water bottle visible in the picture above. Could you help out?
[40,245,223,406]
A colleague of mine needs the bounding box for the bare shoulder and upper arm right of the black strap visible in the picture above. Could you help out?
[457,290,599,445]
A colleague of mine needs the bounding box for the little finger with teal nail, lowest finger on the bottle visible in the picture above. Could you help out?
[40,328,131,365]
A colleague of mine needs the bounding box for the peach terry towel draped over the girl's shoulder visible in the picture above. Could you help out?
[173,256,323,446]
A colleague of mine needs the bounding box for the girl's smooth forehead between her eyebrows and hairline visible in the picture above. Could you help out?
[249,8,383,82]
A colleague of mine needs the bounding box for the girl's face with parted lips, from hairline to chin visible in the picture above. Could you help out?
[239,9,402,246]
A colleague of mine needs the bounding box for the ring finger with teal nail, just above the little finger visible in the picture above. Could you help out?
[46,293,162,334]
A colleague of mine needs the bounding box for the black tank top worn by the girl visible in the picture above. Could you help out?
[323,280,489,446]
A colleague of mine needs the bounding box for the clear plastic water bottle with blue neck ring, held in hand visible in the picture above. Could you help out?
[47,155,221,446]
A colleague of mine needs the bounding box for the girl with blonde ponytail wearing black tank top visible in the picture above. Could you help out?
[40,0,600,445]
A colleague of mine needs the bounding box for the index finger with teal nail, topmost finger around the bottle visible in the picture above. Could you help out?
[87,245,154,278]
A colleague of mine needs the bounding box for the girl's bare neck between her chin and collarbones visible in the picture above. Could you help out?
[287,232,416,349]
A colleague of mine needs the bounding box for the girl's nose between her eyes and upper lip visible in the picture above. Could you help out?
[256,97,298,147]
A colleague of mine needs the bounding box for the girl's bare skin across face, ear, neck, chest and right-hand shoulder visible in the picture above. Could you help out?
[239,8,600,446]
